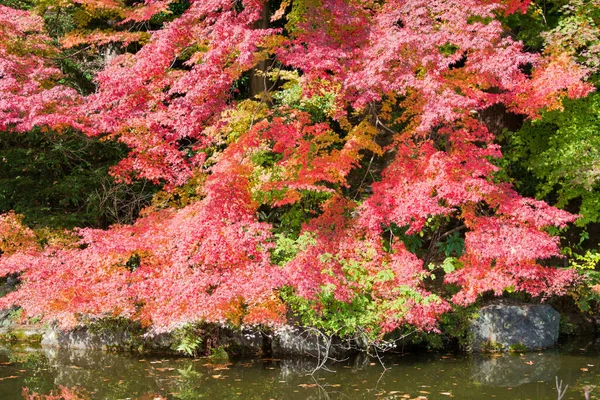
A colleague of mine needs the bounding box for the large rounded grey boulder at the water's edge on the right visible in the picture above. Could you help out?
[471,304,560,352]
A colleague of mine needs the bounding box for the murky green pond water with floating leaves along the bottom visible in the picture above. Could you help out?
[0,340,600,400]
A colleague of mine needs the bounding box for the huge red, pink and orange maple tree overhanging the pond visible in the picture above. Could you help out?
[0,0,593,334]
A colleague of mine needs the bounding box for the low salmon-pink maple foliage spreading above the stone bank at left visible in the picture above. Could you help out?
[0,131,284,332]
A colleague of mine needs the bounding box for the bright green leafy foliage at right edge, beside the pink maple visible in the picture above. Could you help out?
[504,93,600,225]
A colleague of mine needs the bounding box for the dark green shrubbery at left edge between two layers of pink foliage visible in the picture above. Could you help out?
[0,130,153,228]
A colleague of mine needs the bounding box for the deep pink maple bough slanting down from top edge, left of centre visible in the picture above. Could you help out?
[85,0,275,185]
